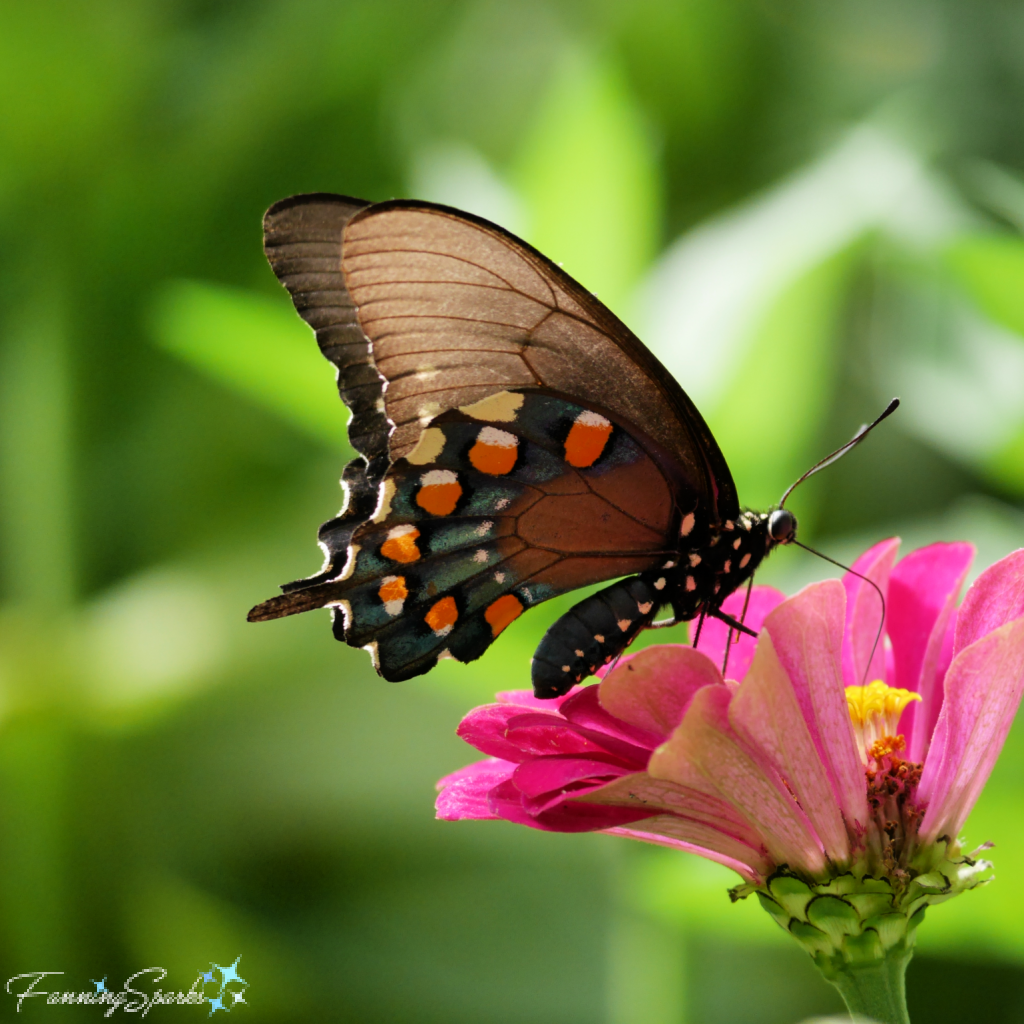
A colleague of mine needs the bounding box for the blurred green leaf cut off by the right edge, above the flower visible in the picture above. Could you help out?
[945,234,1024,337]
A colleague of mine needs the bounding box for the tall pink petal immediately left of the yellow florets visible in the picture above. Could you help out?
[764,580,867,826]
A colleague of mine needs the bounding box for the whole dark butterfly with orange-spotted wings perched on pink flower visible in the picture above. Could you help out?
[249,194,819,697]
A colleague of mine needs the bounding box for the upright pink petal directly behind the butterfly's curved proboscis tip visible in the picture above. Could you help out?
[843,537,899,686]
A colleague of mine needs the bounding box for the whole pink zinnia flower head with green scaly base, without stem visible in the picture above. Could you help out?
[437,540,1024,1011]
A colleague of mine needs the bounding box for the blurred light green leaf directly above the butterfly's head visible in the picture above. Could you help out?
[708,252,851,508]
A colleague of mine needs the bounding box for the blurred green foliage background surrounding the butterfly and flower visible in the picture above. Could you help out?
[0,0,1024,1024]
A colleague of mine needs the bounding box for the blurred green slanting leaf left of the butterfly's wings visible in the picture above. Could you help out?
[152,281,348,451]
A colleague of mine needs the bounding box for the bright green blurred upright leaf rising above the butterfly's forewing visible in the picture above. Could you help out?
[515,52,660,314]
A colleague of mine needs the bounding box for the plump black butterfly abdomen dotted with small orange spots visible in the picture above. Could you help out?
[530,577,659,699]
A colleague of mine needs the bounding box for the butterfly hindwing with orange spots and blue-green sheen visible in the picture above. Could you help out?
[334,392,678,679]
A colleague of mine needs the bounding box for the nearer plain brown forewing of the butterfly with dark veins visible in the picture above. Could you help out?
[342,201,738,519]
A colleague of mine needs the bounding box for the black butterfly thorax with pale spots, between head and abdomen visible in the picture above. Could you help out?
[643,511,775,622]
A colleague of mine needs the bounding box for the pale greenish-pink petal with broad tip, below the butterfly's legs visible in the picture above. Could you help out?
[647,686,825,873]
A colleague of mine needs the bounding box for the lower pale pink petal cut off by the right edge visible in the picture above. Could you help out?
[918,616,1024,843]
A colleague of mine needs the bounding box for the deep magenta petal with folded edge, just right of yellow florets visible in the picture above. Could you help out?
[886,544,974,764]
